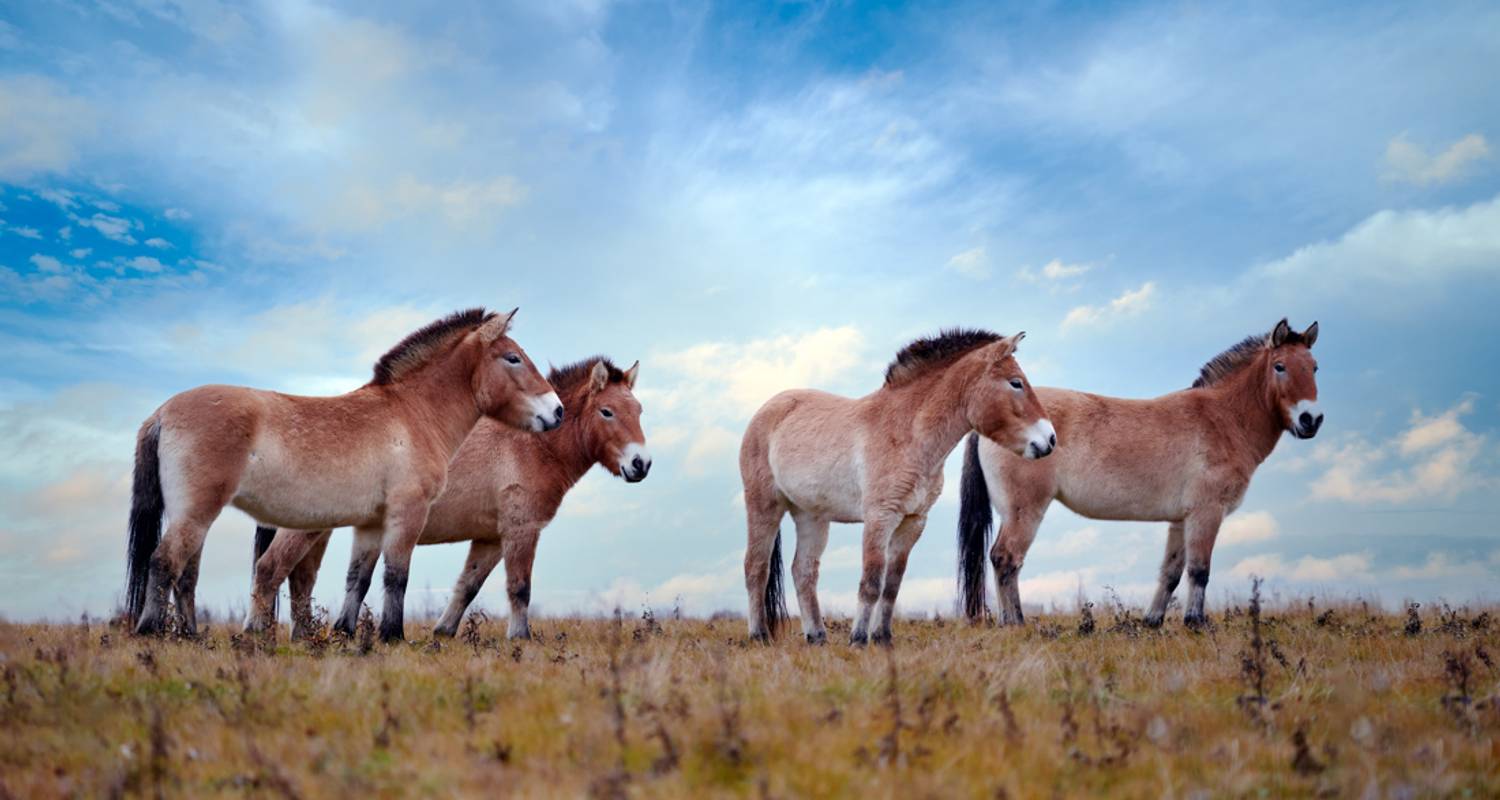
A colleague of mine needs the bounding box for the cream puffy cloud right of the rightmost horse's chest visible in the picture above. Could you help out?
[1313,395,1490,504]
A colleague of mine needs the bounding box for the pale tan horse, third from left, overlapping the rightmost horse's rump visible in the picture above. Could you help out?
[740,330,1056,644]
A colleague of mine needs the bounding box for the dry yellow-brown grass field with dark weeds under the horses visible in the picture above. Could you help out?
[0,588,1500,797]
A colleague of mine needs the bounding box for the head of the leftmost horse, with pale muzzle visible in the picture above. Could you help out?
[474,309,563,431]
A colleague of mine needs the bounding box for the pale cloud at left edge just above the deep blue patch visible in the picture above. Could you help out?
[0,75,95,182]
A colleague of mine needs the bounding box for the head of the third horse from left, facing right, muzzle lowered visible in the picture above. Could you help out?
[968,332,1058,458]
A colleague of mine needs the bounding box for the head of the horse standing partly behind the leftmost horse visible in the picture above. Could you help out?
[573,360,651,483]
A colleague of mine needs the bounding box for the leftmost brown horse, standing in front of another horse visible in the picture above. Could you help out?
[126,309,563,639]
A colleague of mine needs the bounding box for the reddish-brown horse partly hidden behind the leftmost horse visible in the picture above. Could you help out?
[248,356,651,639]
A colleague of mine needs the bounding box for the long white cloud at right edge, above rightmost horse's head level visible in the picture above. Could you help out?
[1250,197,1500,288]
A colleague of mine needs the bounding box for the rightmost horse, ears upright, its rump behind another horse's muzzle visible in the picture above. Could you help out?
[959,320,1323,629]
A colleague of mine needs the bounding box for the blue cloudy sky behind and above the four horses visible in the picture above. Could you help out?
[0,0,1500,620]
